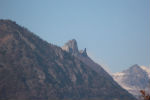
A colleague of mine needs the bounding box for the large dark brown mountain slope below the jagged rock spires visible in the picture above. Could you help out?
[0,20,136,100]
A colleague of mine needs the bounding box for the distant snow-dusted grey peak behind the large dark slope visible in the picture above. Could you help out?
[113,64,150,97]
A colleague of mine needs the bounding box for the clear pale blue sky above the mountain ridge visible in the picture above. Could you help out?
[0,0,150,73]
